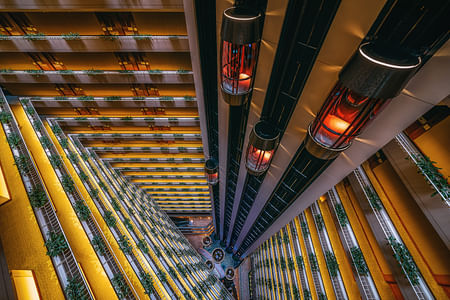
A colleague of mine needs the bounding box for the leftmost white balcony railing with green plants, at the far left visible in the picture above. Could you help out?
[0,90,94,299]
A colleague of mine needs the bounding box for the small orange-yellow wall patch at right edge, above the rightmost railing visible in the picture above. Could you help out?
[414,117,450,178]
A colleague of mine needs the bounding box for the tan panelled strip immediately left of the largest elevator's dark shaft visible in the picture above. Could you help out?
[235,0,385,249]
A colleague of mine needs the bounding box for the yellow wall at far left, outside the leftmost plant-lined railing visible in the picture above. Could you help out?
[0,127,64,299]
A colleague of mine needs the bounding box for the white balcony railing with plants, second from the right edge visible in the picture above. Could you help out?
[353,166,434,299]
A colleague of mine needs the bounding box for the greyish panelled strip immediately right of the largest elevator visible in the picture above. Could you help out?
[245,41,450,255]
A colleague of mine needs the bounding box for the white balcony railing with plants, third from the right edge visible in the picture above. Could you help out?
[328,187,380,300]
